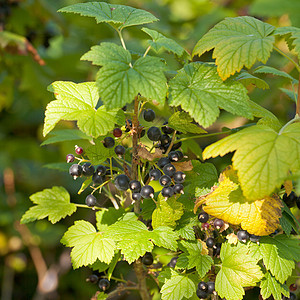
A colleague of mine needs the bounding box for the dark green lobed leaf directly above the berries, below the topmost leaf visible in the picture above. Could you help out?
[82,43,167,109]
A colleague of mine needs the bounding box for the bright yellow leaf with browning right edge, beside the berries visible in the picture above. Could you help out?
[203,168,282,235]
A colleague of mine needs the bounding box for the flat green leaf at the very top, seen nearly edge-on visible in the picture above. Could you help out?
[59,2,158,30]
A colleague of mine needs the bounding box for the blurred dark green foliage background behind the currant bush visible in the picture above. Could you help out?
[0,0,300,300]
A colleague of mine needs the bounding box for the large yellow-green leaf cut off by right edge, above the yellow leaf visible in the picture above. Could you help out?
[203,123,300,200]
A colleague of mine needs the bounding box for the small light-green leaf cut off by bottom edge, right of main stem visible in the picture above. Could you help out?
[161,270,196,300]
